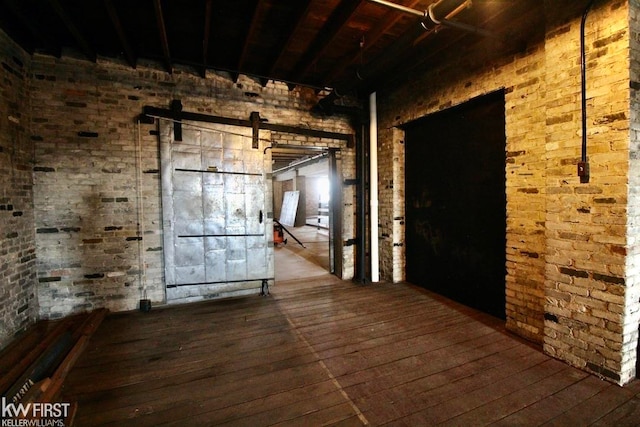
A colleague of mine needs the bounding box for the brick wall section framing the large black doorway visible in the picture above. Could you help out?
[378,37,545,341]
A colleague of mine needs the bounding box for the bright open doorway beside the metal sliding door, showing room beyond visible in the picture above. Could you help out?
[272,145,340,282]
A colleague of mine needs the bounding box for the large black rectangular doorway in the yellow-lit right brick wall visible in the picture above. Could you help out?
[405,91,506,318]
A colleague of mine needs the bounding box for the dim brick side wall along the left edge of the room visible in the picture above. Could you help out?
[0,32,37,348]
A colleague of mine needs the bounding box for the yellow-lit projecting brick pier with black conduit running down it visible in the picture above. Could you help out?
[544,2,638,383]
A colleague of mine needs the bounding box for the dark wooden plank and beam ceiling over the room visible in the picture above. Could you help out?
[0,0,544,93]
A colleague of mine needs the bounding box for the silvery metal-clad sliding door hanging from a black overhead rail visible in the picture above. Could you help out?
[160,121,274,303]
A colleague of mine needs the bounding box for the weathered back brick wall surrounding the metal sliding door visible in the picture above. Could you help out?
[31,55,353,318]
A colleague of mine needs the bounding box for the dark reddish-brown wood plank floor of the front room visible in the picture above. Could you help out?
[63,251,640,426]
